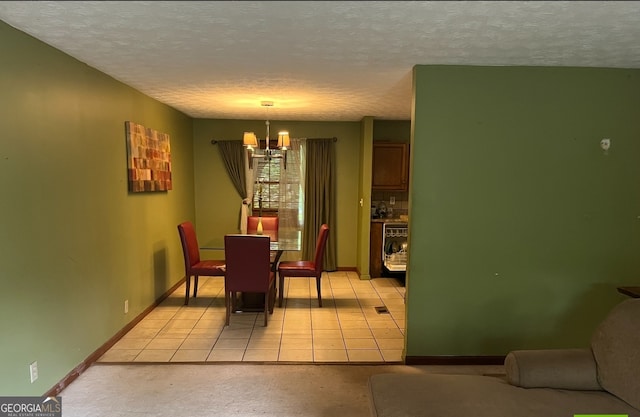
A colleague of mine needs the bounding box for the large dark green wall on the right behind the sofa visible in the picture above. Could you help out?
[406,66,640,356]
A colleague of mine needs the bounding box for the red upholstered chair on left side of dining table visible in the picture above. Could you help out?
[178,222,224,305]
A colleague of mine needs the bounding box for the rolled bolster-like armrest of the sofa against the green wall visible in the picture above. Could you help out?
[504,349,602,391]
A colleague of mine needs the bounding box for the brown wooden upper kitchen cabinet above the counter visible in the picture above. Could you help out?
[371,141,409,191]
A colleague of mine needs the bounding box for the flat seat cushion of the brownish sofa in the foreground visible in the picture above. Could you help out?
[369,373,640,417]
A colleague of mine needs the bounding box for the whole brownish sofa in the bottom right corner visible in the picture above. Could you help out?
[369,299,640,417]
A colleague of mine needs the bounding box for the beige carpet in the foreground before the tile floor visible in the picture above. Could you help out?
[60,363,503,417]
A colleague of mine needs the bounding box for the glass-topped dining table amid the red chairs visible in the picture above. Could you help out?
[200,230,302,312]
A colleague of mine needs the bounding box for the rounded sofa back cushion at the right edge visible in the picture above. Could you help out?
[591,298,640,409]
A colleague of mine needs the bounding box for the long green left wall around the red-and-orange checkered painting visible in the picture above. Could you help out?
[0,22,195,395]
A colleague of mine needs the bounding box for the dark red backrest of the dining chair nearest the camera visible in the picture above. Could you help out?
[224,234,271,292]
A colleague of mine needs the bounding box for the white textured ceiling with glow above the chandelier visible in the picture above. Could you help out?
[0,1,640,121]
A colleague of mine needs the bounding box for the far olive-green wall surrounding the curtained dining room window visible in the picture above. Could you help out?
[193,119,361,268]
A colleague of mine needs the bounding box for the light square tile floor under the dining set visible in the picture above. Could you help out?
[98,271,405,363]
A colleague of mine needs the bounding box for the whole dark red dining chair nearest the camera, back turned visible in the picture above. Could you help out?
[224,235,276,327]
